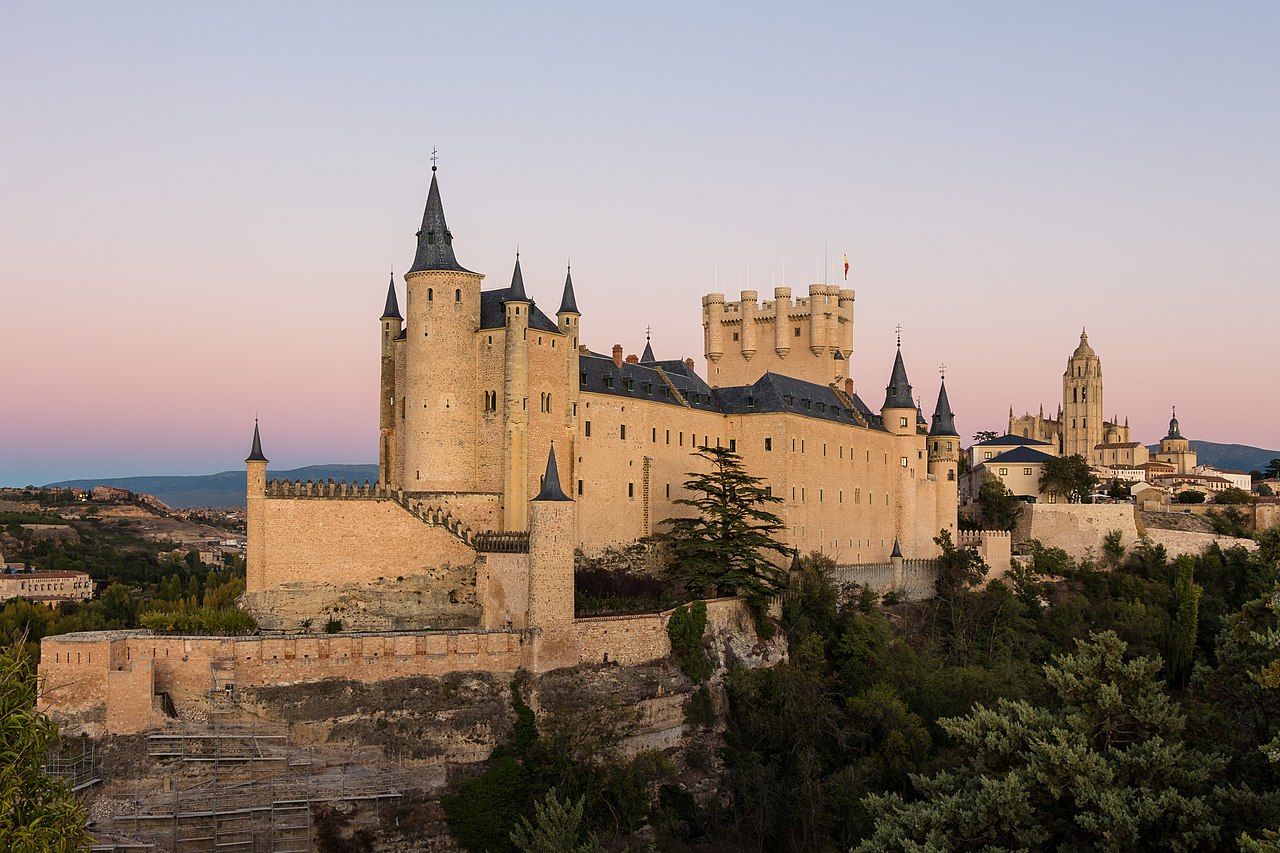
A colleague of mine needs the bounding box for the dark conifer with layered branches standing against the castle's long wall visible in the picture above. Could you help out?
[664,447,790,613]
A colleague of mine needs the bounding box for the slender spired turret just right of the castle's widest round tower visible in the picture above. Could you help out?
[502,252,532,530]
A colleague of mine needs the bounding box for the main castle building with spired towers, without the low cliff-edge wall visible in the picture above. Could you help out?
[241,167,960,625]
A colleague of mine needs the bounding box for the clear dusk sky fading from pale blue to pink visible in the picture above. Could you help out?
[0,1,1280,484]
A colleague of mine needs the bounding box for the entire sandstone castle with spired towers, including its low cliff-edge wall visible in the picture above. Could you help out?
[41,169,967,731]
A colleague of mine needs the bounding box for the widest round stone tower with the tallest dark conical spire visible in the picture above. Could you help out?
[397,167,484,492]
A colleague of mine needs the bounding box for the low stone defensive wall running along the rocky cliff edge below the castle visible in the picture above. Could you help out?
[40,598,750,734]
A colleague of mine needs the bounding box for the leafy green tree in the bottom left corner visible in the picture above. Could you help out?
[0,642,92,853]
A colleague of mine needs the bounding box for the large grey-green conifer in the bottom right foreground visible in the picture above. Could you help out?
[858,631,1222,853]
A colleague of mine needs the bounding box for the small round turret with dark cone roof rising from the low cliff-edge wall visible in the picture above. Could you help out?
[527,446,577,672]
